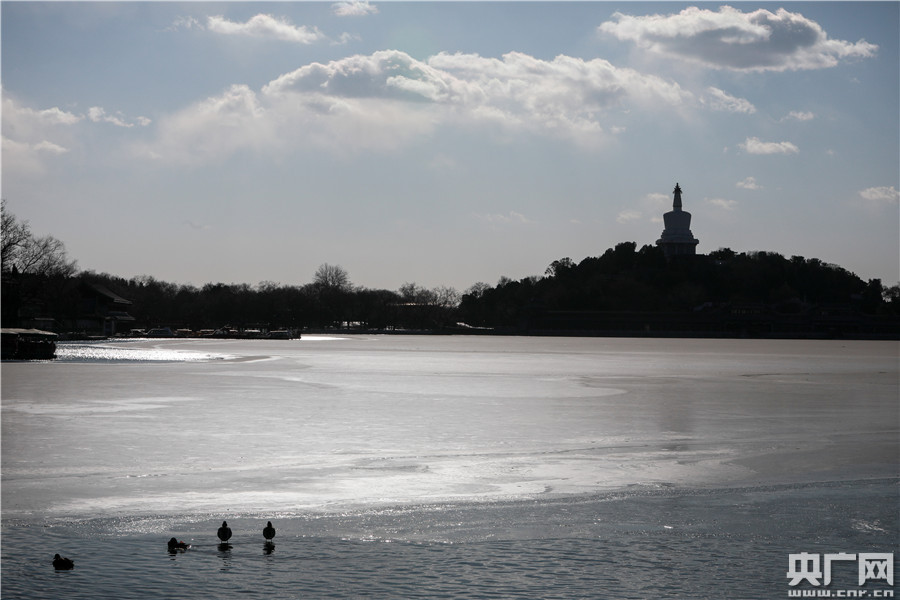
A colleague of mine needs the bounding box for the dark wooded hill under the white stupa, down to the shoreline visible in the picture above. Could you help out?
[458,242,900,337]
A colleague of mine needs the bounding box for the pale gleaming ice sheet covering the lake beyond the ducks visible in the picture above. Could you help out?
[2,336,900,518]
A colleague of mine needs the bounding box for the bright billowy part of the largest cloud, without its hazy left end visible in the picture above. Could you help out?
[263,50,691,148]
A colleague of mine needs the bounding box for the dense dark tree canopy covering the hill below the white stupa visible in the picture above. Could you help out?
[459,242,900,336]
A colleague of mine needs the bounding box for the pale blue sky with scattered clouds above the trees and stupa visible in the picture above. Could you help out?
[0,1,900,292]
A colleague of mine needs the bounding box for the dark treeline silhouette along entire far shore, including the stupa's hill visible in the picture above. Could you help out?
[2,196,900,338]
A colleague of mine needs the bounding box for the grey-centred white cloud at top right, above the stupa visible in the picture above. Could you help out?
[599,6,878,71]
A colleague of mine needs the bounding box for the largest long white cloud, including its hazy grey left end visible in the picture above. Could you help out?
[142,50,751,161]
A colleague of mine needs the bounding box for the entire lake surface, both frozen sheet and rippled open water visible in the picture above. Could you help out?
[0,336,900,600]
